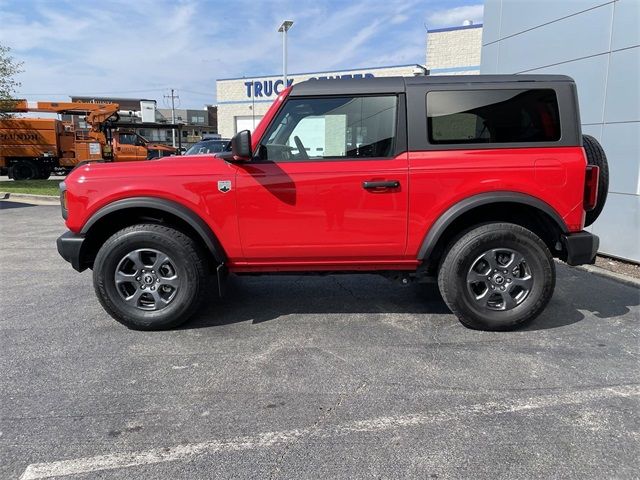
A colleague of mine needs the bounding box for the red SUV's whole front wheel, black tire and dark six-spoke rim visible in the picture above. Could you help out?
[93,224,209,330]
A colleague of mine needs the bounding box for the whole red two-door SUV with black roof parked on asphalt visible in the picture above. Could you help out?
[58,75,608,330]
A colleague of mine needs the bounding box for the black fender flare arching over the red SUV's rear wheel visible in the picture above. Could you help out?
[418,191,569,260]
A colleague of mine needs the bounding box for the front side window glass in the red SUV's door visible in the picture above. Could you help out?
[258,96,398,161]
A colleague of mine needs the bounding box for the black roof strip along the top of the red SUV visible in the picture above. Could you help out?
[291,75,573,97]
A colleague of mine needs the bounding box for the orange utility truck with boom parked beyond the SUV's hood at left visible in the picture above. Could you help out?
[0,101,175,180]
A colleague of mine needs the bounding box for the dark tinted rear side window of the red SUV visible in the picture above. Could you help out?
[427,89,560,144]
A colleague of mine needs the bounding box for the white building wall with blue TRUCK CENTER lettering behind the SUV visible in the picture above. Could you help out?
[216,65,419,138]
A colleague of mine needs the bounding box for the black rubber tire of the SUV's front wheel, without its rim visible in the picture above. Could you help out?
[93,224,210,330]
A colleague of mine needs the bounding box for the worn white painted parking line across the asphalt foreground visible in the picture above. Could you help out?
[20,385,640,480]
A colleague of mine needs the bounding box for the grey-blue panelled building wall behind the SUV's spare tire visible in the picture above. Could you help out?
[481,0,640,262]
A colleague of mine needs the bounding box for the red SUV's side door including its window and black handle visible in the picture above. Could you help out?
[236,95,408,262]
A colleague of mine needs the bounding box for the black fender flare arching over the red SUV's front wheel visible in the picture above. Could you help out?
[80,197,226,263]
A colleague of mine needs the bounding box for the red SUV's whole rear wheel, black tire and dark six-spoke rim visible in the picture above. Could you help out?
[438,223,556,330]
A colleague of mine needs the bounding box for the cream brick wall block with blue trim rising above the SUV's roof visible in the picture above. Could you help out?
[425,25,482,75]
